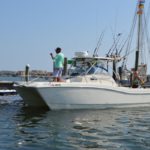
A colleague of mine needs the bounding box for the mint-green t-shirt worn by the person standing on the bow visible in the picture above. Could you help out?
[54,53,64,68]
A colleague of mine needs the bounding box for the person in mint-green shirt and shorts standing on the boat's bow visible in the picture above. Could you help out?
[50,47,64,82]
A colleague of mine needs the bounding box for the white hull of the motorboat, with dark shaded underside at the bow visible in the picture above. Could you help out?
[16,84,150,110]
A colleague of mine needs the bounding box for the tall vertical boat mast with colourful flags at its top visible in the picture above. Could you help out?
[135,0,145,71]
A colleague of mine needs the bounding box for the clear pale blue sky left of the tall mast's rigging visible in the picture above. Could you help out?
[0,0,149,71]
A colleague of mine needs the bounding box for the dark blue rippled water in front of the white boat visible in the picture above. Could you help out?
[0,77,150,150]
